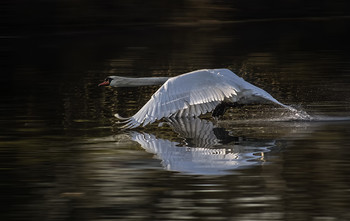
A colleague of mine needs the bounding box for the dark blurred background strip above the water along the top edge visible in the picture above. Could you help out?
[1,0,349,36]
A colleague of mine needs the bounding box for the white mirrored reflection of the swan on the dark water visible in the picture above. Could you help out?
[130,118,275,175]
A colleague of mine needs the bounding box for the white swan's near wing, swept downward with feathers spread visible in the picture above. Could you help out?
[120,70,237,128]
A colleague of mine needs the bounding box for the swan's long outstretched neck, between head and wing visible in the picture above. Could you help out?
[111,77,169,87]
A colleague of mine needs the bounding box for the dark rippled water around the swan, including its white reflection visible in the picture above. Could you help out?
[0,15,350,220]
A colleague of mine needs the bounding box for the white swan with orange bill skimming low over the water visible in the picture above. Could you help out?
[98,69,295,129]
